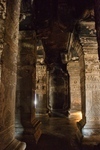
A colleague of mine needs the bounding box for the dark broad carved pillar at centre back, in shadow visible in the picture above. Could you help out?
[48,66,70,116]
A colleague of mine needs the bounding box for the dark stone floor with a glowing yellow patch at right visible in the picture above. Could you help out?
[36,112,100,150]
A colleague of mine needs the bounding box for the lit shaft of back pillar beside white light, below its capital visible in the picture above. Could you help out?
[35,63,47,114]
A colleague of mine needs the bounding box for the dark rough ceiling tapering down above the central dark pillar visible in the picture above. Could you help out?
[20,0,94,64]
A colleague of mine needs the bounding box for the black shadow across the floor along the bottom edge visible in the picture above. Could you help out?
[36,134,100,150]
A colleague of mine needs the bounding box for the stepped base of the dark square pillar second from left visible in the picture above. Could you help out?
[16,119,42,150]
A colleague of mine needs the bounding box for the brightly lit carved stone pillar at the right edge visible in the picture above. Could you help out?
[80,22,100,135]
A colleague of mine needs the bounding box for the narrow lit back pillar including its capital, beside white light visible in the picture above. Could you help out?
[35,40,47,115]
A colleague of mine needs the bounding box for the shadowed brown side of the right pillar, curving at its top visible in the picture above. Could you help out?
[72,31,85,122]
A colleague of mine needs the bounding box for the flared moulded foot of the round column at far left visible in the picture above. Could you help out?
[4,139,26,150]
